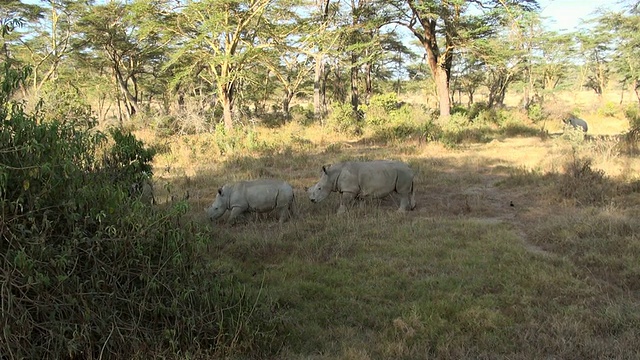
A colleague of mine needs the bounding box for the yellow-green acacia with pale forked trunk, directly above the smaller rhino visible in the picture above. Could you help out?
[167,0,273,129]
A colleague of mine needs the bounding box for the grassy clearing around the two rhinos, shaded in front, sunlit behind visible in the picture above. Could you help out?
[131,106,640,359]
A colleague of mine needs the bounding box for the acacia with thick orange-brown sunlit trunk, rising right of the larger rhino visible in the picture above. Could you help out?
[390,0,537,118]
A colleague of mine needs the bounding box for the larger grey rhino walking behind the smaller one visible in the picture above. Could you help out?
[308,160,416,214]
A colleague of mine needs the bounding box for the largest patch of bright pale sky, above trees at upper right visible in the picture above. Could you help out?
[538,0,623,31]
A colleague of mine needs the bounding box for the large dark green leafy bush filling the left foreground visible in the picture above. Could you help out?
[0,58,278,358]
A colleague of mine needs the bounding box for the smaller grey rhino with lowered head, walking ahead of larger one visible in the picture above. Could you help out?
[204,179,294,224]
